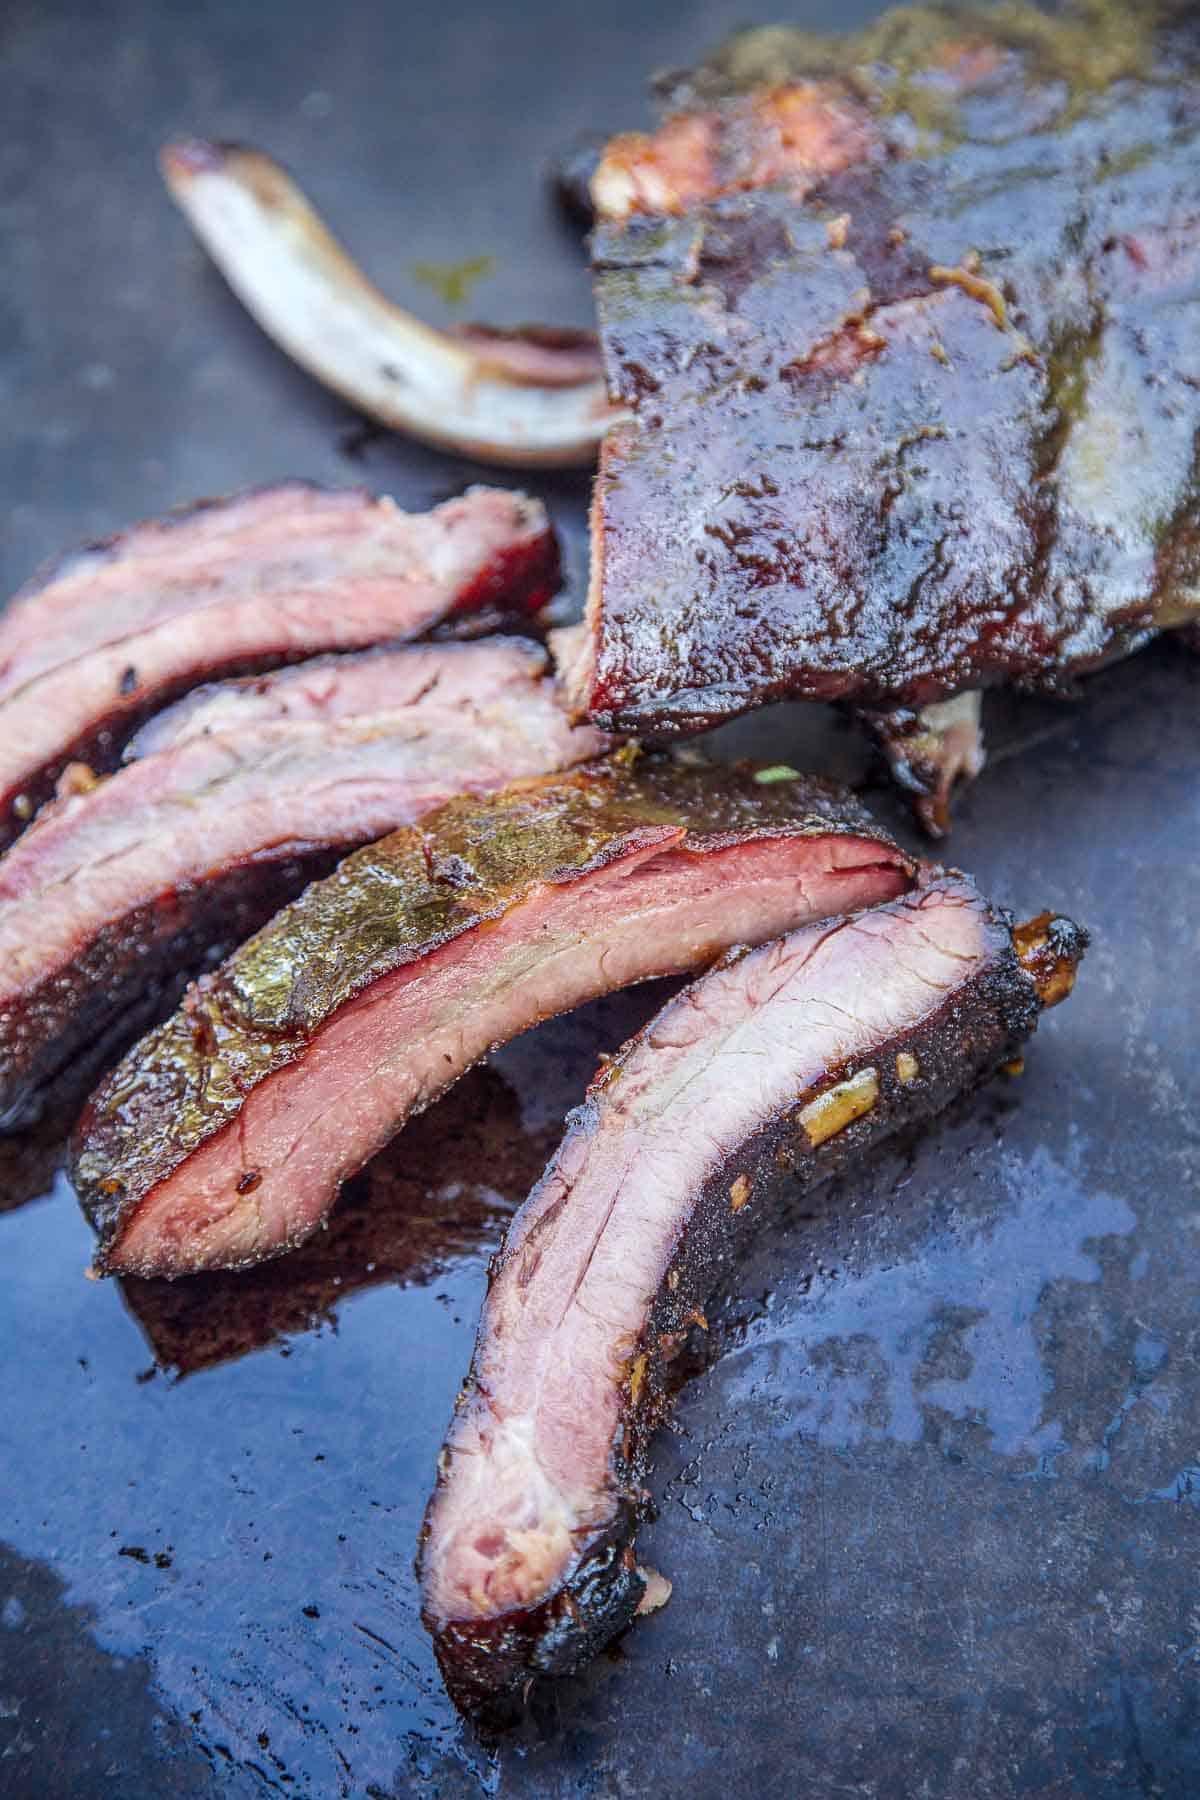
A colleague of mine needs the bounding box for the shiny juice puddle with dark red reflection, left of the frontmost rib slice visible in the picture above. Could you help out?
[0,983,673,1793]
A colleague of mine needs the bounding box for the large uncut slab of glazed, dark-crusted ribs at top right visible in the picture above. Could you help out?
[570,4,1200,730]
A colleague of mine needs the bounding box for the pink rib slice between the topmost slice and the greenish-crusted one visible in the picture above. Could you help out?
[0,637,608,1125]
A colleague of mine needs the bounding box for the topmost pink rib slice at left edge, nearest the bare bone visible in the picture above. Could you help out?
[0,482,558,846]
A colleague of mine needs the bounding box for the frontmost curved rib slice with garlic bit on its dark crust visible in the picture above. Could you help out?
[421,885,1083,1705]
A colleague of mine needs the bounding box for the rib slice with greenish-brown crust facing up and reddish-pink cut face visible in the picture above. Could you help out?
[74,756,912,1274]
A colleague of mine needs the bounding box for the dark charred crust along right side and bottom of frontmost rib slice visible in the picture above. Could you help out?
[416,885,1087,1730]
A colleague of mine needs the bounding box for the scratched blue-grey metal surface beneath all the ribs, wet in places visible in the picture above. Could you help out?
[0,0,1200,1800]
